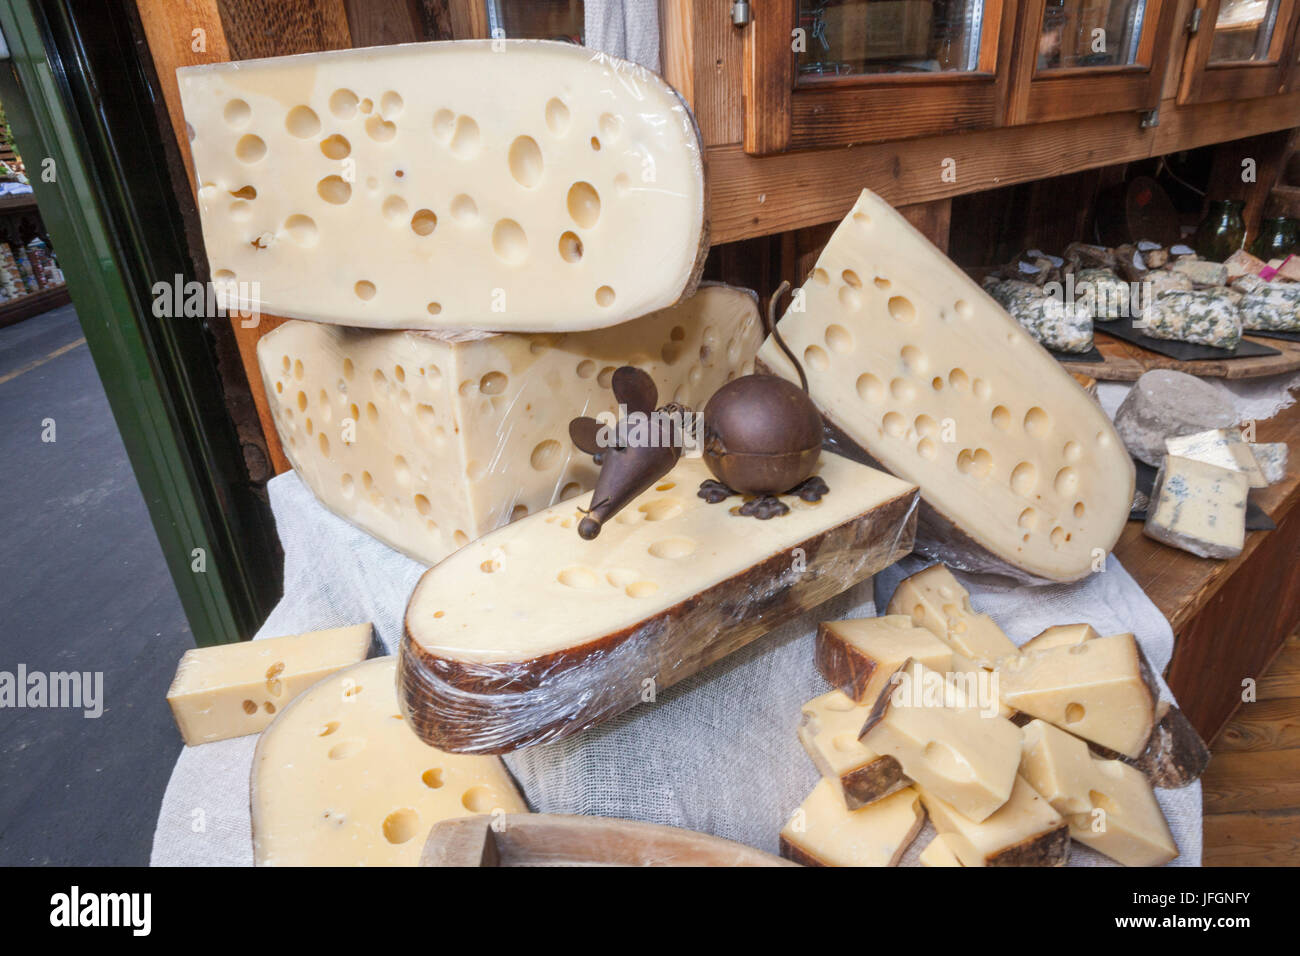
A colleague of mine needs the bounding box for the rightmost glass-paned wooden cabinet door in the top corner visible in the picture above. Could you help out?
[1178,0,1300,103]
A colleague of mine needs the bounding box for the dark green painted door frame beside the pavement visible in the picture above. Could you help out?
[0,0,280,645]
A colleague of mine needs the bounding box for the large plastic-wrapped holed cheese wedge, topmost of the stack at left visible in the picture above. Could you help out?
[177,40,709,332]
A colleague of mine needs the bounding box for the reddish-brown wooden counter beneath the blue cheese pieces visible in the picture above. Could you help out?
[1114,382,1300,741]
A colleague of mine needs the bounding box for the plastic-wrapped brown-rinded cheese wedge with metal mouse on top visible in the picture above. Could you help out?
[400,454,915,753]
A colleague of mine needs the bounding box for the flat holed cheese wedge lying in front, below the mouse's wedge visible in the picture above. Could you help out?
[250,657,528,866]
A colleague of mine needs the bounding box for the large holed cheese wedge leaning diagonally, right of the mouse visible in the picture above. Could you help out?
[759,190,1134,581]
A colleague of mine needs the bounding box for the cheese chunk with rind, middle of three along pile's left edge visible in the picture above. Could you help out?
[798,691,911,810]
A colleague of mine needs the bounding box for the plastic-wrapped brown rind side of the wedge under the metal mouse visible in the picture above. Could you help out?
[398,490,917,753]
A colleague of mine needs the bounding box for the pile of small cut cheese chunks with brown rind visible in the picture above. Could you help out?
[780,564,1208,866]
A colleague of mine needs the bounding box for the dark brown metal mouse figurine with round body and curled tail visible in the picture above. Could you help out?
[569,282,829,540]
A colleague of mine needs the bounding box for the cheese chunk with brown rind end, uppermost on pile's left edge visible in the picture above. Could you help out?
[816,614,953,705]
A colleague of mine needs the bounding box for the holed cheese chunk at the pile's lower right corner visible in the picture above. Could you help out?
[1021,721,1178,866]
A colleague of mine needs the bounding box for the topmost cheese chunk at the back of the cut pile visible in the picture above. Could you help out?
[889,564,1017,666]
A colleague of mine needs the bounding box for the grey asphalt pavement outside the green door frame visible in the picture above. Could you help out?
[0,306,194,866]
